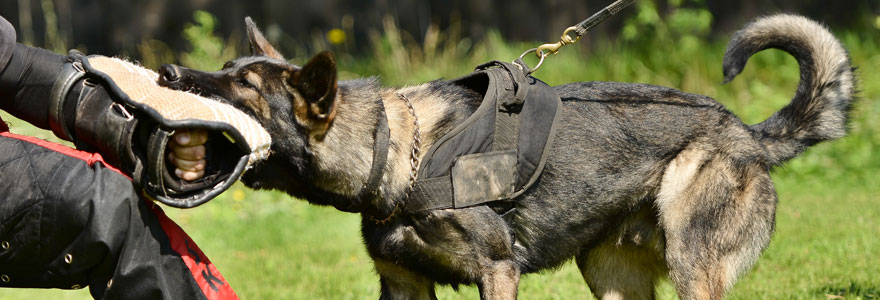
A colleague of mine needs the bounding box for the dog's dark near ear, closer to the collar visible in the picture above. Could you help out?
[288,51,339,135]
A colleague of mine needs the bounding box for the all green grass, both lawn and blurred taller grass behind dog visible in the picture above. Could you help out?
[0,12,880,300]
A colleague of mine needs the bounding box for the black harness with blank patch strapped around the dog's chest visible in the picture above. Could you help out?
[361,61,562,223]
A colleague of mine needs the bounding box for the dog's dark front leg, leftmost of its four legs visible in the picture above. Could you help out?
[374,259,437,300]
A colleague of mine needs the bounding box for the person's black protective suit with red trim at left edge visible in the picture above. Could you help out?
[0,17,236,299]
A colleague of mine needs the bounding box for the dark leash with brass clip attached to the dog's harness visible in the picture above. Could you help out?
[513,0,635,74]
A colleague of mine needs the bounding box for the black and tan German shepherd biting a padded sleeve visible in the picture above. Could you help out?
[160,15,856,299]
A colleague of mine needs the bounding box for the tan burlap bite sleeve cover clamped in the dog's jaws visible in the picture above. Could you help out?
[82,56,272,208]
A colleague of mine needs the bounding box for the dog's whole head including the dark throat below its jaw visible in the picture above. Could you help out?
[159,18,339,192]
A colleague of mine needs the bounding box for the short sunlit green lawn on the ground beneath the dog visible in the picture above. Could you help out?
[0,180,880,299]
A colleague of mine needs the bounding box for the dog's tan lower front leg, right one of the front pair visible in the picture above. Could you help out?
[478,260,520,300]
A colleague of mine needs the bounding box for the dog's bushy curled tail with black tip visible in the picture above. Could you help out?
[724,14,856,165]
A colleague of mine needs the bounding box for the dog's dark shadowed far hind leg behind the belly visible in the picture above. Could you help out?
[577,208,666,300]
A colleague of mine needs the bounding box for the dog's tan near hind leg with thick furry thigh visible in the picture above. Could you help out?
[656,147,776,300]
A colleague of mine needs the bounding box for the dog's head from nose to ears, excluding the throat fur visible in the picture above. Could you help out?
[159,18,337,135]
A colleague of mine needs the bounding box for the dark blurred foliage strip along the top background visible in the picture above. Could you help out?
[6,0,880,60]
